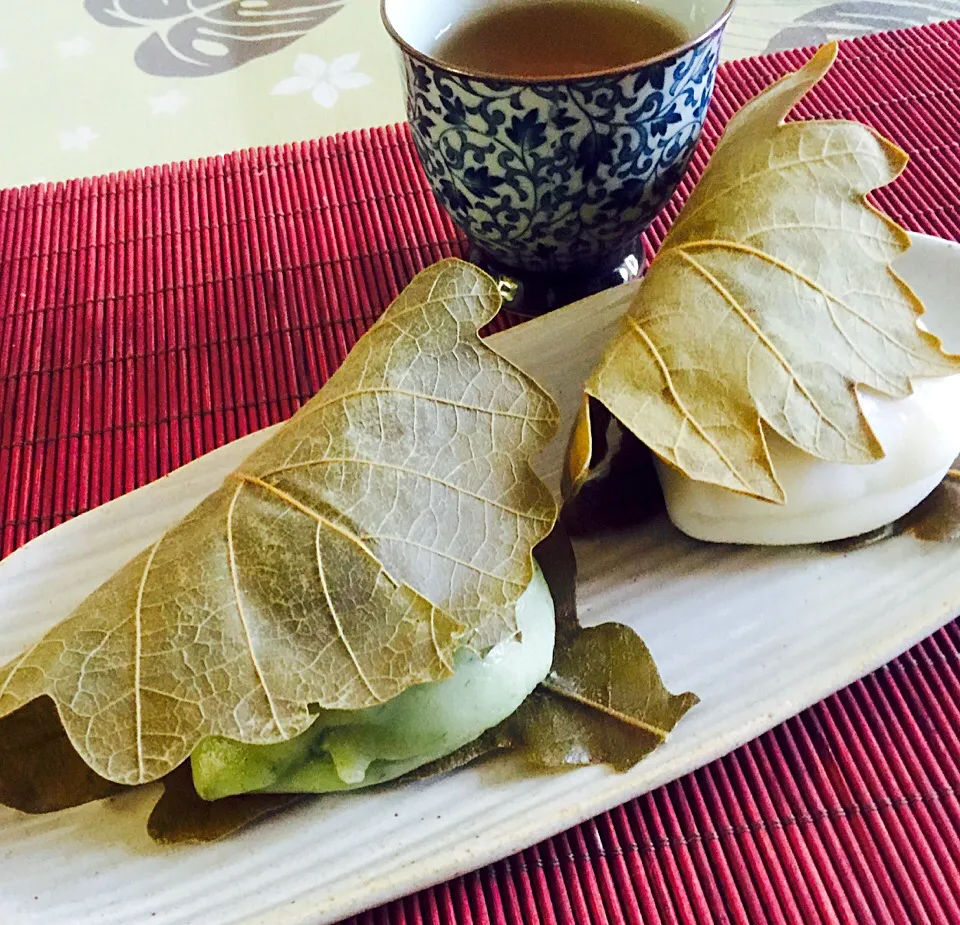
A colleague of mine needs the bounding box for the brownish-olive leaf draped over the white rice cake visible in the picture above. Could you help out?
[568,45,960,503]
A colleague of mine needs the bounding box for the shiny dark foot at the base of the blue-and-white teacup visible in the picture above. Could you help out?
[467,244,647,317]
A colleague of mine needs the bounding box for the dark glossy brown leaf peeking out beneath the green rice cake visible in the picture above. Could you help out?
[148,524,697,844]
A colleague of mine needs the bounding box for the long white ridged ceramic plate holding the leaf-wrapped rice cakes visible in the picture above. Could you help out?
[0,238,960,925]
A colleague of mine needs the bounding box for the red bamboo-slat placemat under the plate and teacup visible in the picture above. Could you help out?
[0,16,960,925]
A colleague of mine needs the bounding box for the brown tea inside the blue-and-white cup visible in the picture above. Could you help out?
[435,0,690,78]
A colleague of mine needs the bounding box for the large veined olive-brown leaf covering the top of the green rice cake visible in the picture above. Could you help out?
[0,261,558,792]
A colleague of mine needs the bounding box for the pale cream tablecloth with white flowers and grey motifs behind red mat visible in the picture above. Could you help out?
[0,0,960,187]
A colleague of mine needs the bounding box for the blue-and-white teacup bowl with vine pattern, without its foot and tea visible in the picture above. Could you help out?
[381,0,733,310]
